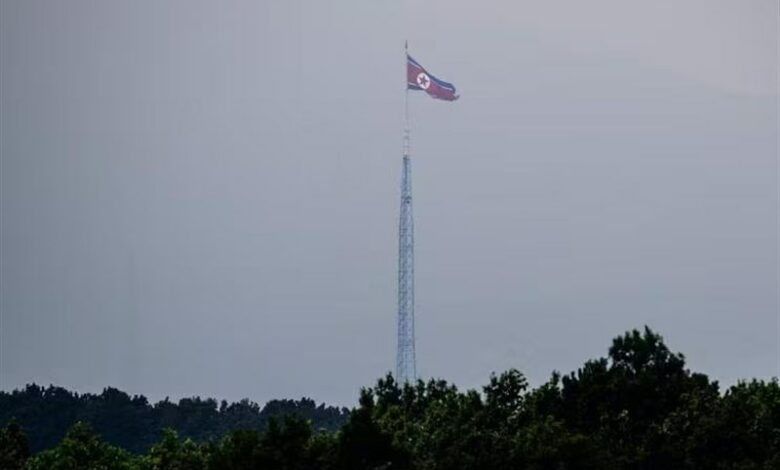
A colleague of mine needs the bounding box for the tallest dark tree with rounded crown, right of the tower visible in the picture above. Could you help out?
[558,327,718,468]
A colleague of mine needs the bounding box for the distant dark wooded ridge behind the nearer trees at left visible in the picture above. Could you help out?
[0,385,347,454]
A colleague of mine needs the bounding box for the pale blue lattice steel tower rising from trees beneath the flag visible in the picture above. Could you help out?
[395,115,417,383]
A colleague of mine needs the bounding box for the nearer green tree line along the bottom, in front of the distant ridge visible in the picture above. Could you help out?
[0,328,780,470]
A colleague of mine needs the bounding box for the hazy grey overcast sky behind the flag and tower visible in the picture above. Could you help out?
[0,0,780,405]
